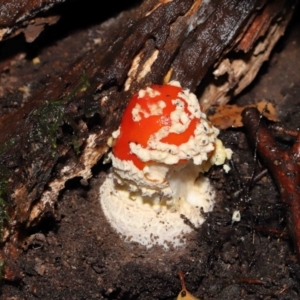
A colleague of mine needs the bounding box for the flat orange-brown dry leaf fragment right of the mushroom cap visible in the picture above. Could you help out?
[208,100,279,129]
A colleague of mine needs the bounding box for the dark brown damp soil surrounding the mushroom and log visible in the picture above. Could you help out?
[0,1,300,300]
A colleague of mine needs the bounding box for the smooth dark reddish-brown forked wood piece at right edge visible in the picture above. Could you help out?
[242,108,300,261]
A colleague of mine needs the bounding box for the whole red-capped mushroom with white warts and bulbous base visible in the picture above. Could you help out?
[100,81,232,249]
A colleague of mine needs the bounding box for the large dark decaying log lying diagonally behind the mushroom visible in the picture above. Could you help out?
[0,0,296,258]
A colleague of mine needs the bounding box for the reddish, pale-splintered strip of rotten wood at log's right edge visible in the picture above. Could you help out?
[200,1,296,108]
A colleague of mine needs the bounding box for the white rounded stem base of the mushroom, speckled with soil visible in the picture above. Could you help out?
[100,174,214,250]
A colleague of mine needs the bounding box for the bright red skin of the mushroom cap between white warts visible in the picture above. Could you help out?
[113,84,200,170]
